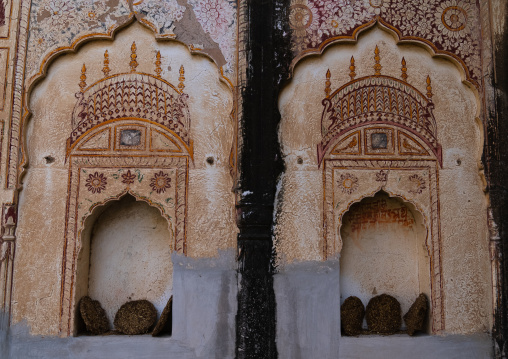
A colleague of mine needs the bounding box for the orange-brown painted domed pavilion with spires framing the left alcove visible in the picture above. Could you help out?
[60,44,193,336]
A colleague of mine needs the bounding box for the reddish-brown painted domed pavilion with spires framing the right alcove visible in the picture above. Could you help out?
[317,48,444,333]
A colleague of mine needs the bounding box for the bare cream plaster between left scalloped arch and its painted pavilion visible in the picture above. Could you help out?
[12,23,236,335]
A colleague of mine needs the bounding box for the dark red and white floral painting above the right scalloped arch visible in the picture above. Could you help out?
[289,0,481,86]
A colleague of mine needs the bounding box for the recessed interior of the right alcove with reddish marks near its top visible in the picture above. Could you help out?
[340,191,431,333]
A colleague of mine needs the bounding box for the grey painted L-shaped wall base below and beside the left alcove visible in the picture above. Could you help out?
[0,250,237,359]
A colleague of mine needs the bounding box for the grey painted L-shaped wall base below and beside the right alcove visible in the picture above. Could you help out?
[274,260,493,359]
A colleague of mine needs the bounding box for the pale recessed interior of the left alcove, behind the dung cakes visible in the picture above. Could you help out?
[74,194,173,335]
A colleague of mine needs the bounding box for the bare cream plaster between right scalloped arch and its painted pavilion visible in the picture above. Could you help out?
[275,27,492,334]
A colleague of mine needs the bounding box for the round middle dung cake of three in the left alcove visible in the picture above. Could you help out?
[114,299,157,335]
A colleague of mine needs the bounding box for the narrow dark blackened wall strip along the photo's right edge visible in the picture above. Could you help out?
[482,0,508,357]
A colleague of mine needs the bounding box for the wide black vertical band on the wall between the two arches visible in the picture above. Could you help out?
[236,0,292,359]
